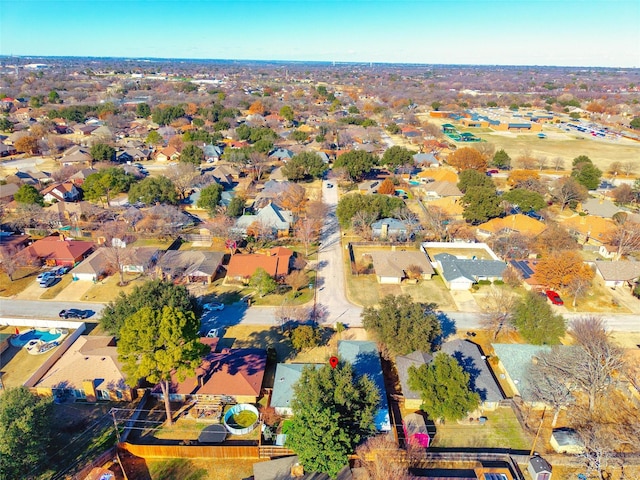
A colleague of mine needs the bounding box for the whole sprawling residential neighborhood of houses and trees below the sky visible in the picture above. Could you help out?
[0,57,640,480]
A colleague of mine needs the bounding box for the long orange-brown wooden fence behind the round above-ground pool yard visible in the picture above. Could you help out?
[118,442,260,459]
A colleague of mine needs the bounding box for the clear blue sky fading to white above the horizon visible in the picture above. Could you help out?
[0,0,640,67]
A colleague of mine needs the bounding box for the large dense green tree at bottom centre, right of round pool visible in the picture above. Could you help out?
[286,363,380,478]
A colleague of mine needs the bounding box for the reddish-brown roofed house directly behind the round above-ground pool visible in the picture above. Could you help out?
[158,348,267,403]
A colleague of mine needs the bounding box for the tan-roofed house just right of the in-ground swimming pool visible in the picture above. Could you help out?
[34,335,134,402]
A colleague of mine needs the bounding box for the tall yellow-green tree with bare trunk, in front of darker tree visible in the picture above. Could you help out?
[118,306,207,425]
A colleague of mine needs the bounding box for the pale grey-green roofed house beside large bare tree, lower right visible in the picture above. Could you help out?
[491,343,551,402]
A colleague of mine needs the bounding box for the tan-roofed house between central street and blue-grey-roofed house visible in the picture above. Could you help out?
[369,249,435,285]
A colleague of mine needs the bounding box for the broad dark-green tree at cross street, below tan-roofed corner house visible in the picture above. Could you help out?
[361,295,442,356]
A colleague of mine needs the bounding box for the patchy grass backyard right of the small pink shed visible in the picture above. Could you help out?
[431,408,531,450]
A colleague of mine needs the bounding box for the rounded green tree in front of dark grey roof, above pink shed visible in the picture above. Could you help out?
[409,353,480,420]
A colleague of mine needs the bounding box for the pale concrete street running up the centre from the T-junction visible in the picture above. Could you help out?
[316,181,362,327]
